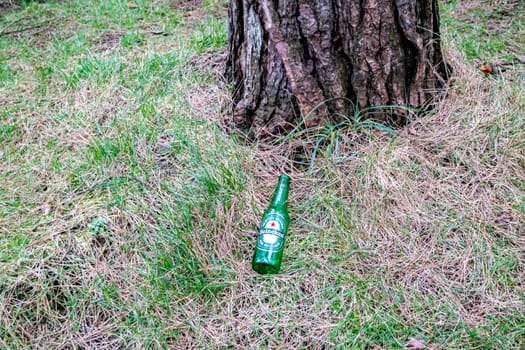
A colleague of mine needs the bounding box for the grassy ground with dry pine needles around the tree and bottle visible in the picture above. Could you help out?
[0,0,525,349]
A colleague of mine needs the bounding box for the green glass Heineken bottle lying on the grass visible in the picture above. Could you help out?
[252,175,290,274]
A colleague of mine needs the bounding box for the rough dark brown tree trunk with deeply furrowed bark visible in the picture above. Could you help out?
[226,0,446,136]
